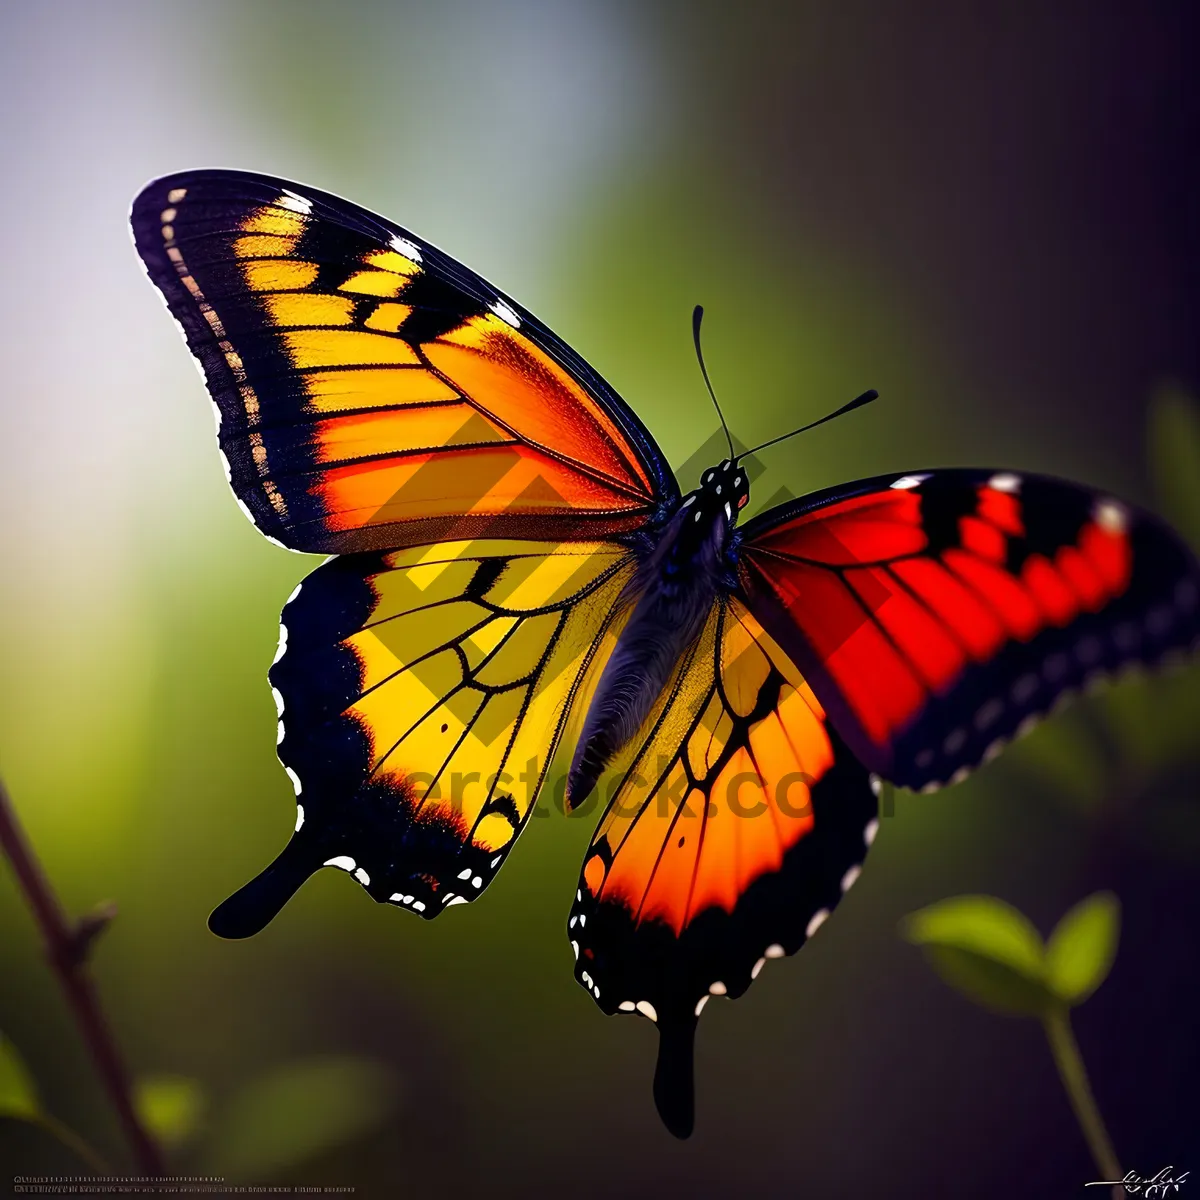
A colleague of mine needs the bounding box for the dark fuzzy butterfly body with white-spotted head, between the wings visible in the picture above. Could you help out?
[568,461,750,805]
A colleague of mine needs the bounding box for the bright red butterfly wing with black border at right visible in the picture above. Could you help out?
[738,470,1200,788]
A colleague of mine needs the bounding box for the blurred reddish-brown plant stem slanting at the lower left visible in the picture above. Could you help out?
[0,780,163,1175]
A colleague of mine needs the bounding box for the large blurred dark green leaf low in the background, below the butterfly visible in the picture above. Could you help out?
[205,1057,396,1178]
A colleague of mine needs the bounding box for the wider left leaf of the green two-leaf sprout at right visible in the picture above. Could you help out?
[901,895,1055,1016]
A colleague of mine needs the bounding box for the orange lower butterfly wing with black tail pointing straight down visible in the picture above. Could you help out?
[568,596,877,1136]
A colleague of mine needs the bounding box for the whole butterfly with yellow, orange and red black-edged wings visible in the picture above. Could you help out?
[132,170,1200,1136]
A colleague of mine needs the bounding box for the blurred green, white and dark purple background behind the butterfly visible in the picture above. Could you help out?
[0,0,1200,1198]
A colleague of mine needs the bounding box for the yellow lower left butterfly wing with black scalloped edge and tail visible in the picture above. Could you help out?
[209,540,634,937]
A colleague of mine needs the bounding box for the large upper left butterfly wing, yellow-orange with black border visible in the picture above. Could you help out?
[132,170,678,553]
